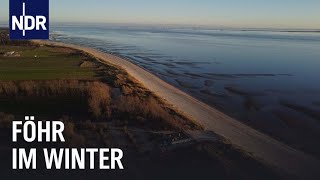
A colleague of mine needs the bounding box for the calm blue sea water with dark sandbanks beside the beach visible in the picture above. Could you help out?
[51,25,320,155]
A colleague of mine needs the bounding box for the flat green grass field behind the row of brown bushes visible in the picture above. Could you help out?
[0,45,96,81]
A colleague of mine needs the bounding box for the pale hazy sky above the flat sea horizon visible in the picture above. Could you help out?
[0,0,320,29]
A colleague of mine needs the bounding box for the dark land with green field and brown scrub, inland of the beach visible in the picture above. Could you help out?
[0,32,284,180]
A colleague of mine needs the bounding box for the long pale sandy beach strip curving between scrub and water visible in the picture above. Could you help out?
[33,41,320,179]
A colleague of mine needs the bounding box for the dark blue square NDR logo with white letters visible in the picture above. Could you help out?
[9,0,49,40]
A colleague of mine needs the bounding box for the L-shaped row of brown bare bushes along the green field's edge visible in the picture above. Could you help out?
[0,80,111,118]
